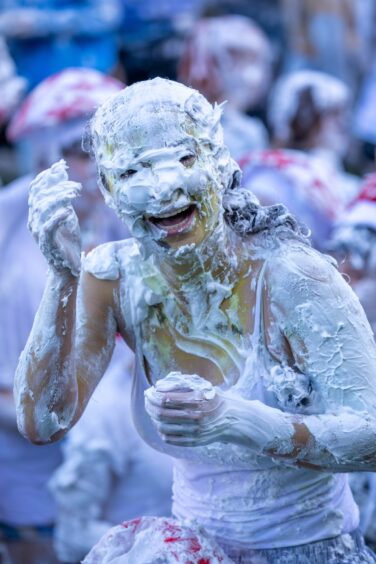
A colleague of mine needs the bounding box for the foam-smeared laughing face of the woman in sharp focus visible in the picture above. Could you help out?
[100,116,222,248]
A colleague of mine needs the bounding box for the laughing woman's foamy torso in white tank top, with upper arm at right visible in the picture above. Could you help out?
[85,234,372,548]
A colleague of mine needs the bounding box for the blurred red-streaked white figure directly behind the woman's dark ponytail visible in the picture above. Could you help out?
[239,149,341,250]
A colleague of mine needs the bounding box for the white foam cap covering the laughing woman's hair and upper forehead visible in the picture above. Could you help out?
[91,78,223,161]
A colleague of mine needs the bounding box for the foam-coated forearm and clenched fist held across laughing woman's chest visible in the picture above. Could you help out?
[146,373,376,472]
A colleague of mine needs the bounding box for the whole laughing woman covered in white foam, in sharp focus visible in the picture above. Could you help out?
[15,79,376,563]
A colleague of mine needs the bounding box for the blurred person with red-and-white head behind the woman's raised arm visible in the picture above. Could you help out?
[0,69,124,564]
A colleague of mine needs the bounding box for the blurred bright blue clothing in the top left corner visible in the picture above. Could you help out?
[0,0,121,89]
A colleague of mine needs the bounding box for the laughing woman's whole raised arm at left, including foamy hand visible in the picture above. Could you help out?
[15,162,117,444]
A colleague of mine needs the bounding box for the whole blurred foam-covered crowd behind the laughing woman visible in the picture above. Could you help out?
[0,0,376,564]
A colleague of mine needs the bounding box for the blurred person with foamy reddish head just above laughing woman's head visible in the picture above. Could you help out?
[178,15,272,159]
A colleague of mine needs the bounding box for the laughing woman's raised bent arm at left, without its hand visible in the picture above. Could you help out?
[14,270,116,444]
